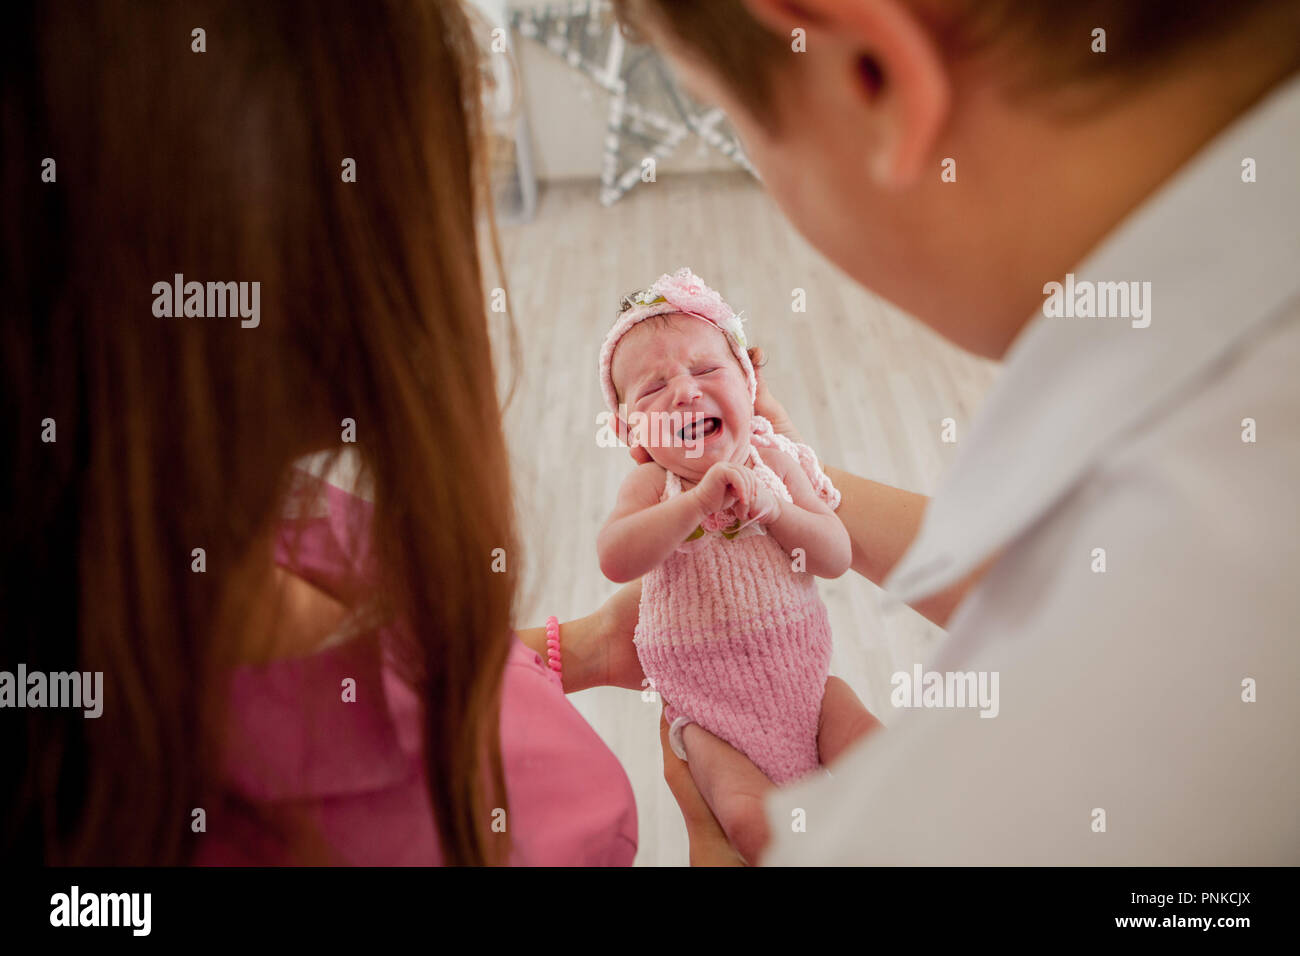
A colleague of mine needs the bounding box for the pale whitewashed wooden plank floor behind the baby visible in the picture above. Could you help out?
[494,173,996,865]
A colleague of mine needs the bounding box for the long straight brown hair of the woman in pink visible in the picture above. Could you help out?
[0,0,517,864]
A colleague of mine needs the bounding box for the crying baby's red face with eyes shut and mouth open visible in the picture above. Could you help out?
[611,313,754,481]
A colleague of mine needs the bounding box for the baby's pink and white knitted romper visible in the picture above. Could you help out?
[636,446,837,784]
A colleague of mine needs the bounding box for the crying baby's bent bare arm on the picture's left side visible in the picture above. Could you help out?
[595,462,702,584]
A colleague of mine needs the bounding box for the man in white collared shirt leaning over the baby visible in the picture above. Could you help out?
[616,0,1300,865]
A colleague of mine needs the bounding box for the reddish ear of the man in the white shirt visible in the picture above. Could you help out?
[744,0,953,187]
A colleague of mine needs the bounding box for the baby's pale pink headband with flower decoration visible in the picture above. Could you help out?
[601,268,758,415]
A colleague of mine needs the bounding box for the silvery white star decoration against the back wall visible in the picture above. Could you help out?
[510,0,757,206]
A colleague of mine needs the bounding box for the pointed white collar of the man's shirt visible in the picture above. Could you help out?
[884,74,1300,602]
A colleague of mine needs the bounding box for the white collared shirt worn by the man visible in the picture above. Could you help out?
[763,70,1300,865]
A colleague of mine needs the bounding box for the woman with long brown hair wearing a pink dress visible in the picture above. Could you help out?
[0,0,640,864]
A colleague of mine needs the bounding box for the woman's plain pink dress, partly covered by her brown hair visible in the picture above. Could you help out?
[196,486,637,866]
